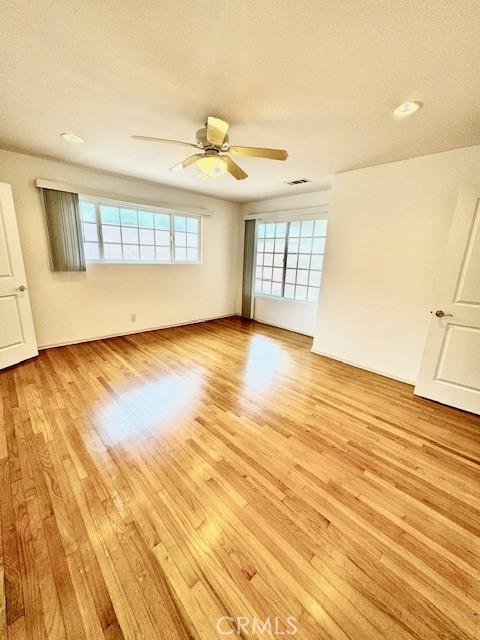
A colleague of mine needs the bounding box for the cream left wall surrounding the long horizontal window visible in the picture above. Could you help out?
[0,151,242,346]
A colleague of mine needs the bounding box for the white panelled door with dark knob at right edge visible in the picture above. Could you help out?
[415,185,480,413]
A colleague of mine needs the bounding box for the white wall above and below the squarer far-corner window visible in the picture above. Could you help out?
[242,187,331,336]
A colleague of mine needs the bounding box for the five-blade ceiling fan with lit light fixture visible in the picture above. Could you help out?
[132,116,288,180]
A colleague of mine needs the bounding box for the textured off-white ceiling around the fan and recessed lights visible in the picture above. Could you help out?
[0,0,480,202]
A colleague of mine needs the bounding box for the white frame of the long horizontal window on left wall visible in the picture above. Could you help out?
[79,194,204,266]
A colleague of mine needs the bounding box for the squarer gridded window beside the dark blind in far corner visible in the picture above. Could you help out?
[255,220,327,302]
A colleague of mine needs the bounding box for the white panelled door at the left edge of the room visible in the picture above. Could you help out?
[0,182,38,369]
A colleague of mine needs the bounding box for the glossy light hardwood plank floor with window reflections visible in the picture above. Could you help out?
[0,318,480,640]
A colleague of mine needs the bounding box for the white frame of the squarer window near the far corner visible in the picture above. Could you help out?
[255,211,328,305]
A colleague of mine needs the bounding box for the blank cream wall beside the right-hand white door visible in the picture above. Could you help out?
[313,146,480,382]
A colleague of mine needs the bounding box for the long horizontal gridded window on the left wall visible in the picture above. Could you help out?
[80,200,200,263]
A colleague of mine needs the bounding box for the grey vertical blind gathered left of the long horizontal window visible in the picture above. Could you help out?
[42,189,86,271]
